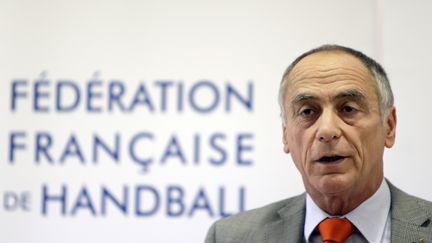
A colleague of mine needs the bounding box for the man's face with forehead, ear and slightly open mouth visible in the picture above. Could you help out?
[283,51,396,199]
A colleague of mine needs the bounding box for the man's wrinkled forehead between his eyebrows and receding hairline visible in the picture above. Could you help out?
[286,51,376,98]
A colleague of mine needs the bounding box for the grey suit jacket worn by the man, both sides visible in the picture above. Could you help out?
[205,183,432,243]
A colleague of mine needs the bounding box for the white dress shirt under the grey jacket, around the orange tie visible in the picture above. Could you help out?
[304,180,391,243]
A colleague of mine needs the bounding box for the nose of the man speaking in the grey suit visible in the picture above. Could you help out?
[316,110,342,143]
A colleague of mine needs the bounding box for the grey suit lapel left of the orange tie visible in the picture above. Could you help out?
[264,194,306,243]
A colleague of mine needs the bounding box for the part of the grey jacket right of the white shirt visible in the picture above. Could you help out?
[388,182,432,243]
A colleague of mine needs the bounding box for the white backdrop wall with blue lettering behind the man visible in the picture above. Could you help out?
[0,0,432,243]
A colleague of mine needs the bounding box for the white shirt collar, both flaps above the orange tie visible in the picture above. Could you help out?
[304,180,391,242]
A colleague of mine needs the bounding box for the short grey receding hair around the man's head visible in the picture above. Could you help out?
[279,45,394,124]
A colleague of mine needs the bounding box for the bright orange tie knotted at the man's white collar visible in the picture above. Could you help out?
[318,218,354,243]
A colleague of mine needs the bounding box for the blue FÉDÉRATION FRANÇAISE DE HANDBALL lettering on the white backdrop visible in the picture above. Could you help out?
[1,71,255,217]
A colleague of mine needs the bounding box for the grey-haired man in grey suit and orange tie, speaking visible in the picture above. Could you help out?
[206,45,432,243]
